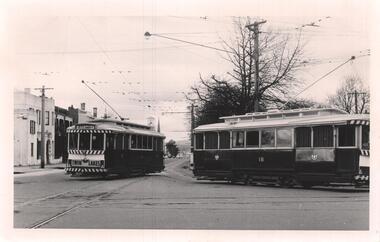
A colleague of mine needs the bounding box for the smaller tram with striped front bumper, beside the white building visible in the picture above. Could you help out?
[65,119,165,177]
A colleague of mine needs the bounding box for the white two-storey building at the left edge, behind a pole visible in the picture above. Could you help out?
[14,88,55,166]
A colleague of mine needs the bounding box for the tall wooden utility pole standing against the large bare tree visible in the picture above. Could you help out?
[246,20,267,112]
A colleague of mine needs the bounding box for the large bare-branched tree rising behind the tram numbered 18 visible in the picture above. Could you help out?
[192,18,303,124]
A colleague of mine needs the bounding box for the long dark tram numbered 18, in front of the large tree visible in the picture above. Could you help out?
[190,108,369,187]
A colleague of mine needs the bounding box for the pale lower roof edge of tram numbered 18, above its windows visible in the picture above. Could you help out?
[194,114,369,132]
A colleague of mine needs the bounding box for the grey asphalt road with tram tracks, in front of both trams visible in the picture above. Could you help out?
[14,159,369,230]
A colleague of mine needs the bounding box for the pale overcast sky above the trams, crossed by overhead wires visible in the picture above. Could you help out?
[1,0,371,140]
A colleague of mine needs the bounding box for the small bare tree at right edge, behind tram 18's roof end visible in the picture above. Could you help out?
[328,75,370,113]
